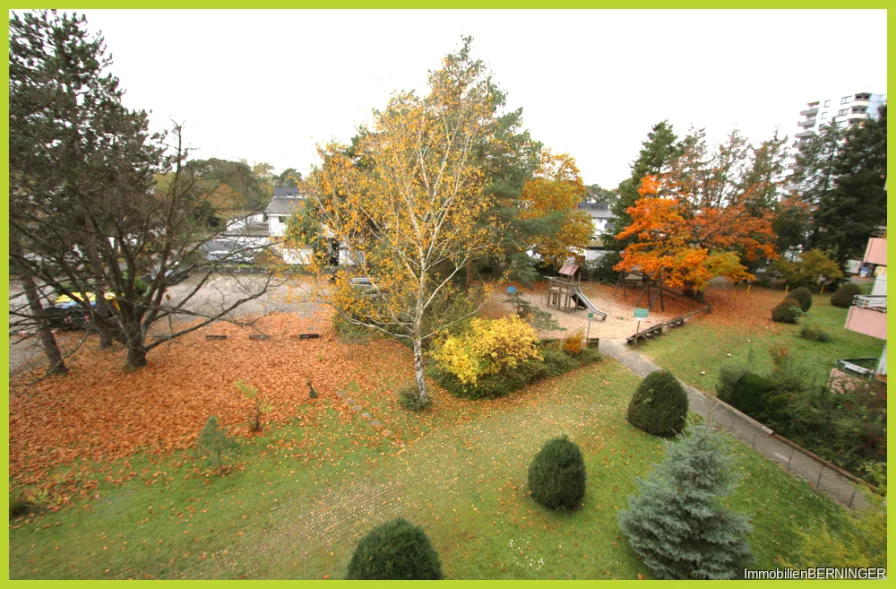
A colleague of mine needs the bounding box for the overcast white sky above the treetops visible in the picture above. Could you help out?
[68,10,887,188]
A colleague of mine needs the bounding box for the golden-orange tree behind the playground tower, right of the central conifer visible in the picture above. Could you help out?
[520,149,594,266]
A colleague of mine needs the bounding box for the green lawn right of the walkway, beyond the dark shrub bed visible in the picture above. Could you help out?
[639,288,884,393]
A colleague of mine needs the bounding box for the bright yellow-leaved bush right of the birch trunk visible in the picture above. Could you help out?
[433,315,543,386]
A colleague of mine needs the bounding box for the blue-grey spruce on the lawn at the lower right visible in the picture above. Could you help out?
[618,427,752,579]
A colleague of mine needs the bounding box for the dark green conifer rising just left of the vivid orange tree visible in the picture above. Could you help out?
[610,121,681,247]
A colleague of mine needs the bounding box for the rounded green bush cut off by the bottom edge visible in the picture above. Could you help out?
[345,518,443,581]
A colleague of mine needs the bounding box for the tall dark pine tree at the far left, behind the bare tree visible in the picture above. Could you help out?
[9,11,159,347]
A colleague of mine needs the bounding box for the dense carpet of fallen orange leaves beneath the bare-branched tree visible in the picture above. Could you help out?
[9,314,412,484]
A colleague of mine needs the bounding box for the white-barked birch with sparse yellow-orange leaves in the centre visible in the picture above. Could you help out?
[287,41,508,400]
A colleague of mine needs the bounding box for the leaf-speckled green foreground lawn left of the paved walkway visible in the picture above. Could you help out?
[9,356,845,579]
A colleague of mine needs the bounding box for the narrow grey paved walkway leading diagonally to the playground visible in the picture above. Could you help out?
[600,339,867,507]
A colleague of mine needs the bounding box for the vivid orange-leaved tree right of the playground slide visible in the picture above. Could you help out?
[615,176,777,299]
